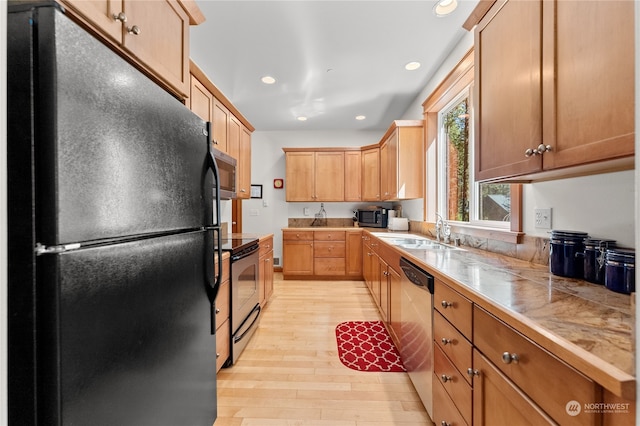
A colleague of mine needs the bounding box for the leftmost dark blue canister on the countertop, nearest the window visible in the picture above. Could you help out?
[549,230,589,278]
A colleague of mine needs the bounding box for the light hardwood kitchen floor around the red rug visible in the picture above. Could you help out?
[215,273,432,426]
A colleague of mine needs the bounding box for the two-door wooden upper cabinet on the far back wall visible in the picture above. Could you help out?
[283,148,344,201]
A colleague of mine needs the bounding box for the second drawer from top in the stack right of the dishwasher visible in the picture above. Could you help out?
[433,311,473,384]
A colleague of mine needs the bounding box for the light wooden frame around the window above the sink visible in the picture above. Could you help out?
[422,48,523,243]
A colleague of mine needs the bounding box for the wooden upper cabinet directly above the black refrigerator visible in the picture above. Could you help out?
[62,0,204,99]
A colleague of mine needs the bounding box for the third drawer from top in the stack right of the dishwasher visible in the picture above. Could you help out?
[433,345,472,424]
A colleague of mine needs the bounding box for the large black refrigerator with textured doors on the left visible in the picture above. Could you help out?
[7,2,220,426]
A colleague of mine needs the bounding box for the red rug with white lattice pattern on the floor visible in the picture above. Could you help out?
[336,321,406,371]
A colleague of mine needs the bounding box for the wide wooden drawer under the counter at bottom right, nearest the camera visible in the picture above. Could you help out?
[473,306,602,425]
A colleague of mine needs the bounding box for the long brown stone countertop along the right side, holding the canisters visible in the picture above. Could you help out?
[364,230,635,400]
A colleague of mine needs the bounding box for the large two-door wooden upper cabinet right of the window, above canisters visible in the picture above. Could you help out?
[475,0,635,181]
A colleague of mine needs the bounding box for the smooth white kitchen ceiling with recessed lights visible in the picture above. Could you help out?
[191,0,478,130]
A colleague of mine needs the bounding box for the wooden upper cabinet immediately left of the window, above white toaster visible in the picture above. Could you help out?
[380,120,424,200]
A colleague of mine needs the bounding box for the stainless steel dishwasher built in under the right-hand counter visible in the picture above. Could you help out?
[400,257,434,418]
